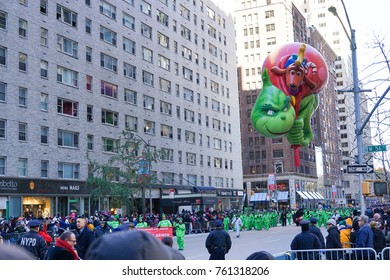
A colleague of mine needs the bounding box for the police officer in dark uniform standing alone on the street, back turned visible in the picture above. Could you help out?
[206,220,232,260]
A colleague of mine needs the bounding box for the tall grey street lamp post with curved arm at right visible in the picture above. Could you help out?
[328,0,366,211]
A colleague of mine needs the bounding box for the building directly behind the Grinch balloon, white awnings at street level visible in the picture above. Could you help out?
[235,0,339,208]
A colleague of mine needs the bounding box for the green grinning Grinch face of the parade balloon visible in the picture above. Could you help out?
[251,71,295,138]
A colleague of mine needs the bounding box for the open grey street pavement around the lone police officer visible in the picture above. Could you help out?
[173,224,327,260]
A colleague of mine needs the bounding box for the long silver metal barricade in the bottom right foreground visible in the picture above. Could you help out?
[284,248,378,260]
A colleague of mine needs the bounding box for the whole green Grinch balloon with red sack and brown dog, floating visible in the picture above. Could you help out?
[251,43,328,166]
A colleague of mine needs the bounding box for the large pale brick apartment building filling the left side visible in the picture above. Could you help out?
[0,0,244,216]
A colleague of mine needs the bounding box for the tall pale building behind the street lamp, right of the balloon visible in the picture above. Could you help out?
[293,0,372,205]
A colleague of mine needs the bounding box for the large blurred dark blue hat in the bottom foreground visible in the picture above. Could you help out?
[85,230,185,260]
